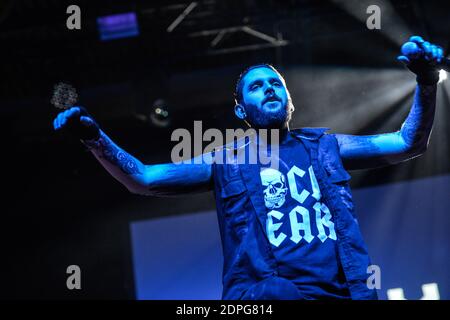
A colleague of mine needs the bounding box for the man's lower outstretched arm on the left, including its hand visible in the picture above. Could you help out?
[54,107,212,196]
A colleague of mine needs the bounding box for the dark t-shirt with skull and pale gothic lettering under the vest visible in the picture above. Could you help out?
[261,135,349,298]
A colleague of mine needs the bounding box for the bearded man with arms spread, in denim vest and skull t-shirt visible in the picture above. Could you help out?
[54,36,443,300]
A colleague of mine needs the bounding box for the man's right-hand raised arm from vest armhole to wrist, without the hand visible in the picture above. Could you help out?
[335,84,436,170]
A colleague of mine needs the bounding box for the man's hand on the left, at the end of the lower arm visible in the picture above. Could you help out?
[53,107,100,140]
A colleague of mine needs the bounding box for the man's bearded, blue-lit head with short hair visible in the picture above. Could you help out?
[241,67,290,129]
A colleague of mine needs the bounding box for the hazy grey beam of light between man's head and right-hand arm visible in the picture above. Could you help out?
[285,67,416,134]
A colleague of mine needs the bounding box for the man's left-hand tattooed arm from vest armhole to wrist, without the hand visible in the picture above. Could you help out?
[84,131,212,196]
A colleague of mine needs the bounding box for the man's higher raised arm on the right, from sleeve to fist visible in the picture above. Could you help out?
[335,37,443,170]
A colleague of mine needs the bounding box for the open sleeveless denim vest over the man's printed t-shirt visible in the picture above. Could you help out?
[212,128,377,299]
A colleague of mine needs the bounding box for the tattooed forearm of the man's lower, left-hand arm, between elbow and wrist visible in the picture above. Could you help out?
[84,133,141,174]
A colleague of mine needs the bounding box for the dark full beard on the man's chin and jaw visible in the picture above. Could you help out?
[245,100,291,129]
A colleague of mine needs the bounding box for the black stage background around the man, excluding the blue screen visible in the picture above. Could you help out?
[0,0,450,299]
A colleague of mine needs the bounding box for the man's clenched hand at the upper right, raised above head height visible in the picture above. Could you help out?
[397,36,444,85]
